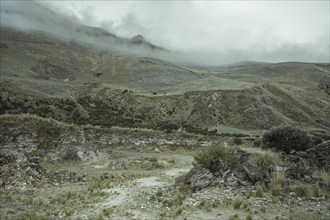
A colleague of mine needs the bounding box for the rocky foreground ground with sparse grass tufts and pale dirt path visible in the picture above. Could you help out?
[0,115,330,219]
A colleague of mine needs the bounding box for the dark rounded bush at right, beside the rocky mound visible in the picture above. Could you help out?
[262,126,311,153]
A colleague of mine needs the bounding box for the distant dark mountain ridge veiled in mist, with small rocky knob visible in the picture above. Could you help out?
[1,1,168,56]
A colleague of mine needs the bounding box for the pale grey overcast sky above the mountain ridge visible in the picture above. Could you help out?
[28,0,330,63]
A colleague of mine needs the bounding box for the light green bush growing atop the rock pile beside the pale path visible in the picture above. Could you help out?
[194,146,238,171]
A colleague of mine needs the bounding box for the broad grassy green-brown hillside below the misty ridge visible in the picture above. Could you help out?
[1,27,330,135]
